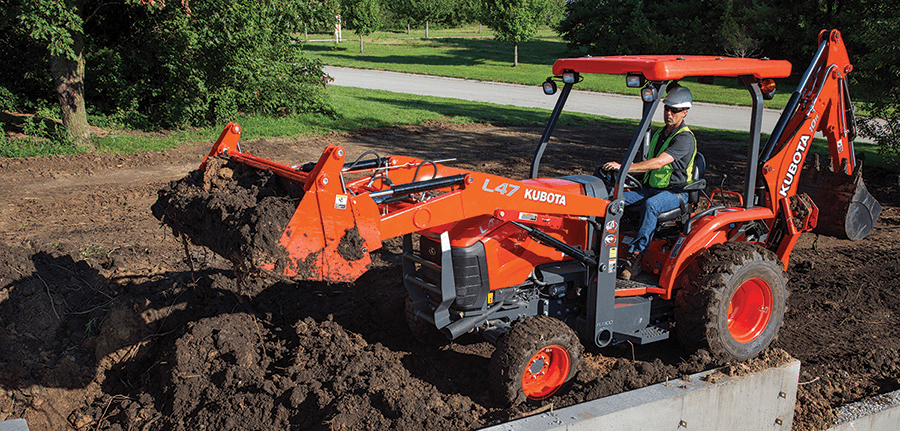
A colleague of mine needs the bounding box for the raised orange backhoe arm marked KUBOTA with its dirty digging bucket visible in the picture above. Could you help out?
[761,30,881,246]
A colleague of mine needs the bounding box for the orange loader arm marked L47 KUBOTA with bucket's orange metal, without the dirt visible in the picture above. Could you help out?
[201,124,609,282]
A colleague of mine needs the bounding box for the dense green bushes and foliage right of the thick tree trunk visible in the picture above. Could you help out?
[77,0,331,129]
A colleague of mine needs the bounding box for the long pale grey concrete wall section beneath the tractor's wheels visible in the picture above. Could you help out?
[486,361,800,431]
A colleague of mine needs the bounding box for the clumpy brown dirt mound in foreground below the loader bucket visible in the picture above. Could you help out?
[150,314,480,430]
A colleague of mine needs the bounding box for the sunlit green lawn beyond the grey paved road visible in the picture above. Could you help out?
[301,27,796,109]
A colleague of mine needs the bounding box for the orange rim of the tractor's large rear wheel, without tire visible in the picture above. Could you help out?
[728,278,772,343]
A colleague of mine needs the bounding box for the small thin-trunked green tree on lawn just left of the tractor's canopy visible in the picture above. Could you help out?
[481,0,564,67]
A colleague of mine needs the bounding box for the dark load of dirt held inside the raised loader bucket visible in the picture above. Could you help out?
[151,157,303,295]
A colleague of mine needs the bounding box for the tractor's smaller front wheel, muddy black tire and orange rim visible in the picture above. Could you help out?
[489,316,583,405]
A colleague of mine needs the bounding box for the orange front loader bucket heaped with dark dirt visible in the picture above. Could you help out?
[152,125,381,282]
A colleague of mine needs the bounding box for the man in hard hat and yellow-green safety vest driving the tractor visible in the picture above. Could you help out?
[602,85,697,280]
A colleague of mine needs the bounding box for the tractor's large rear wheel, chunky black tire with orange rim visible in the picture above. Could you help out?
[675,242,788,361]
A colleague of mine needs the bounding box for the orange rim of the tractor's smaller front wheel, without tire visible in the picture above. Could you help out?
[522,345,572,400]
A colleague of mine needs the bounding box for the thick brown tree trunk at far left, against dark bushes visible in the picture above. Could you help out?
[50,33,95,150]
